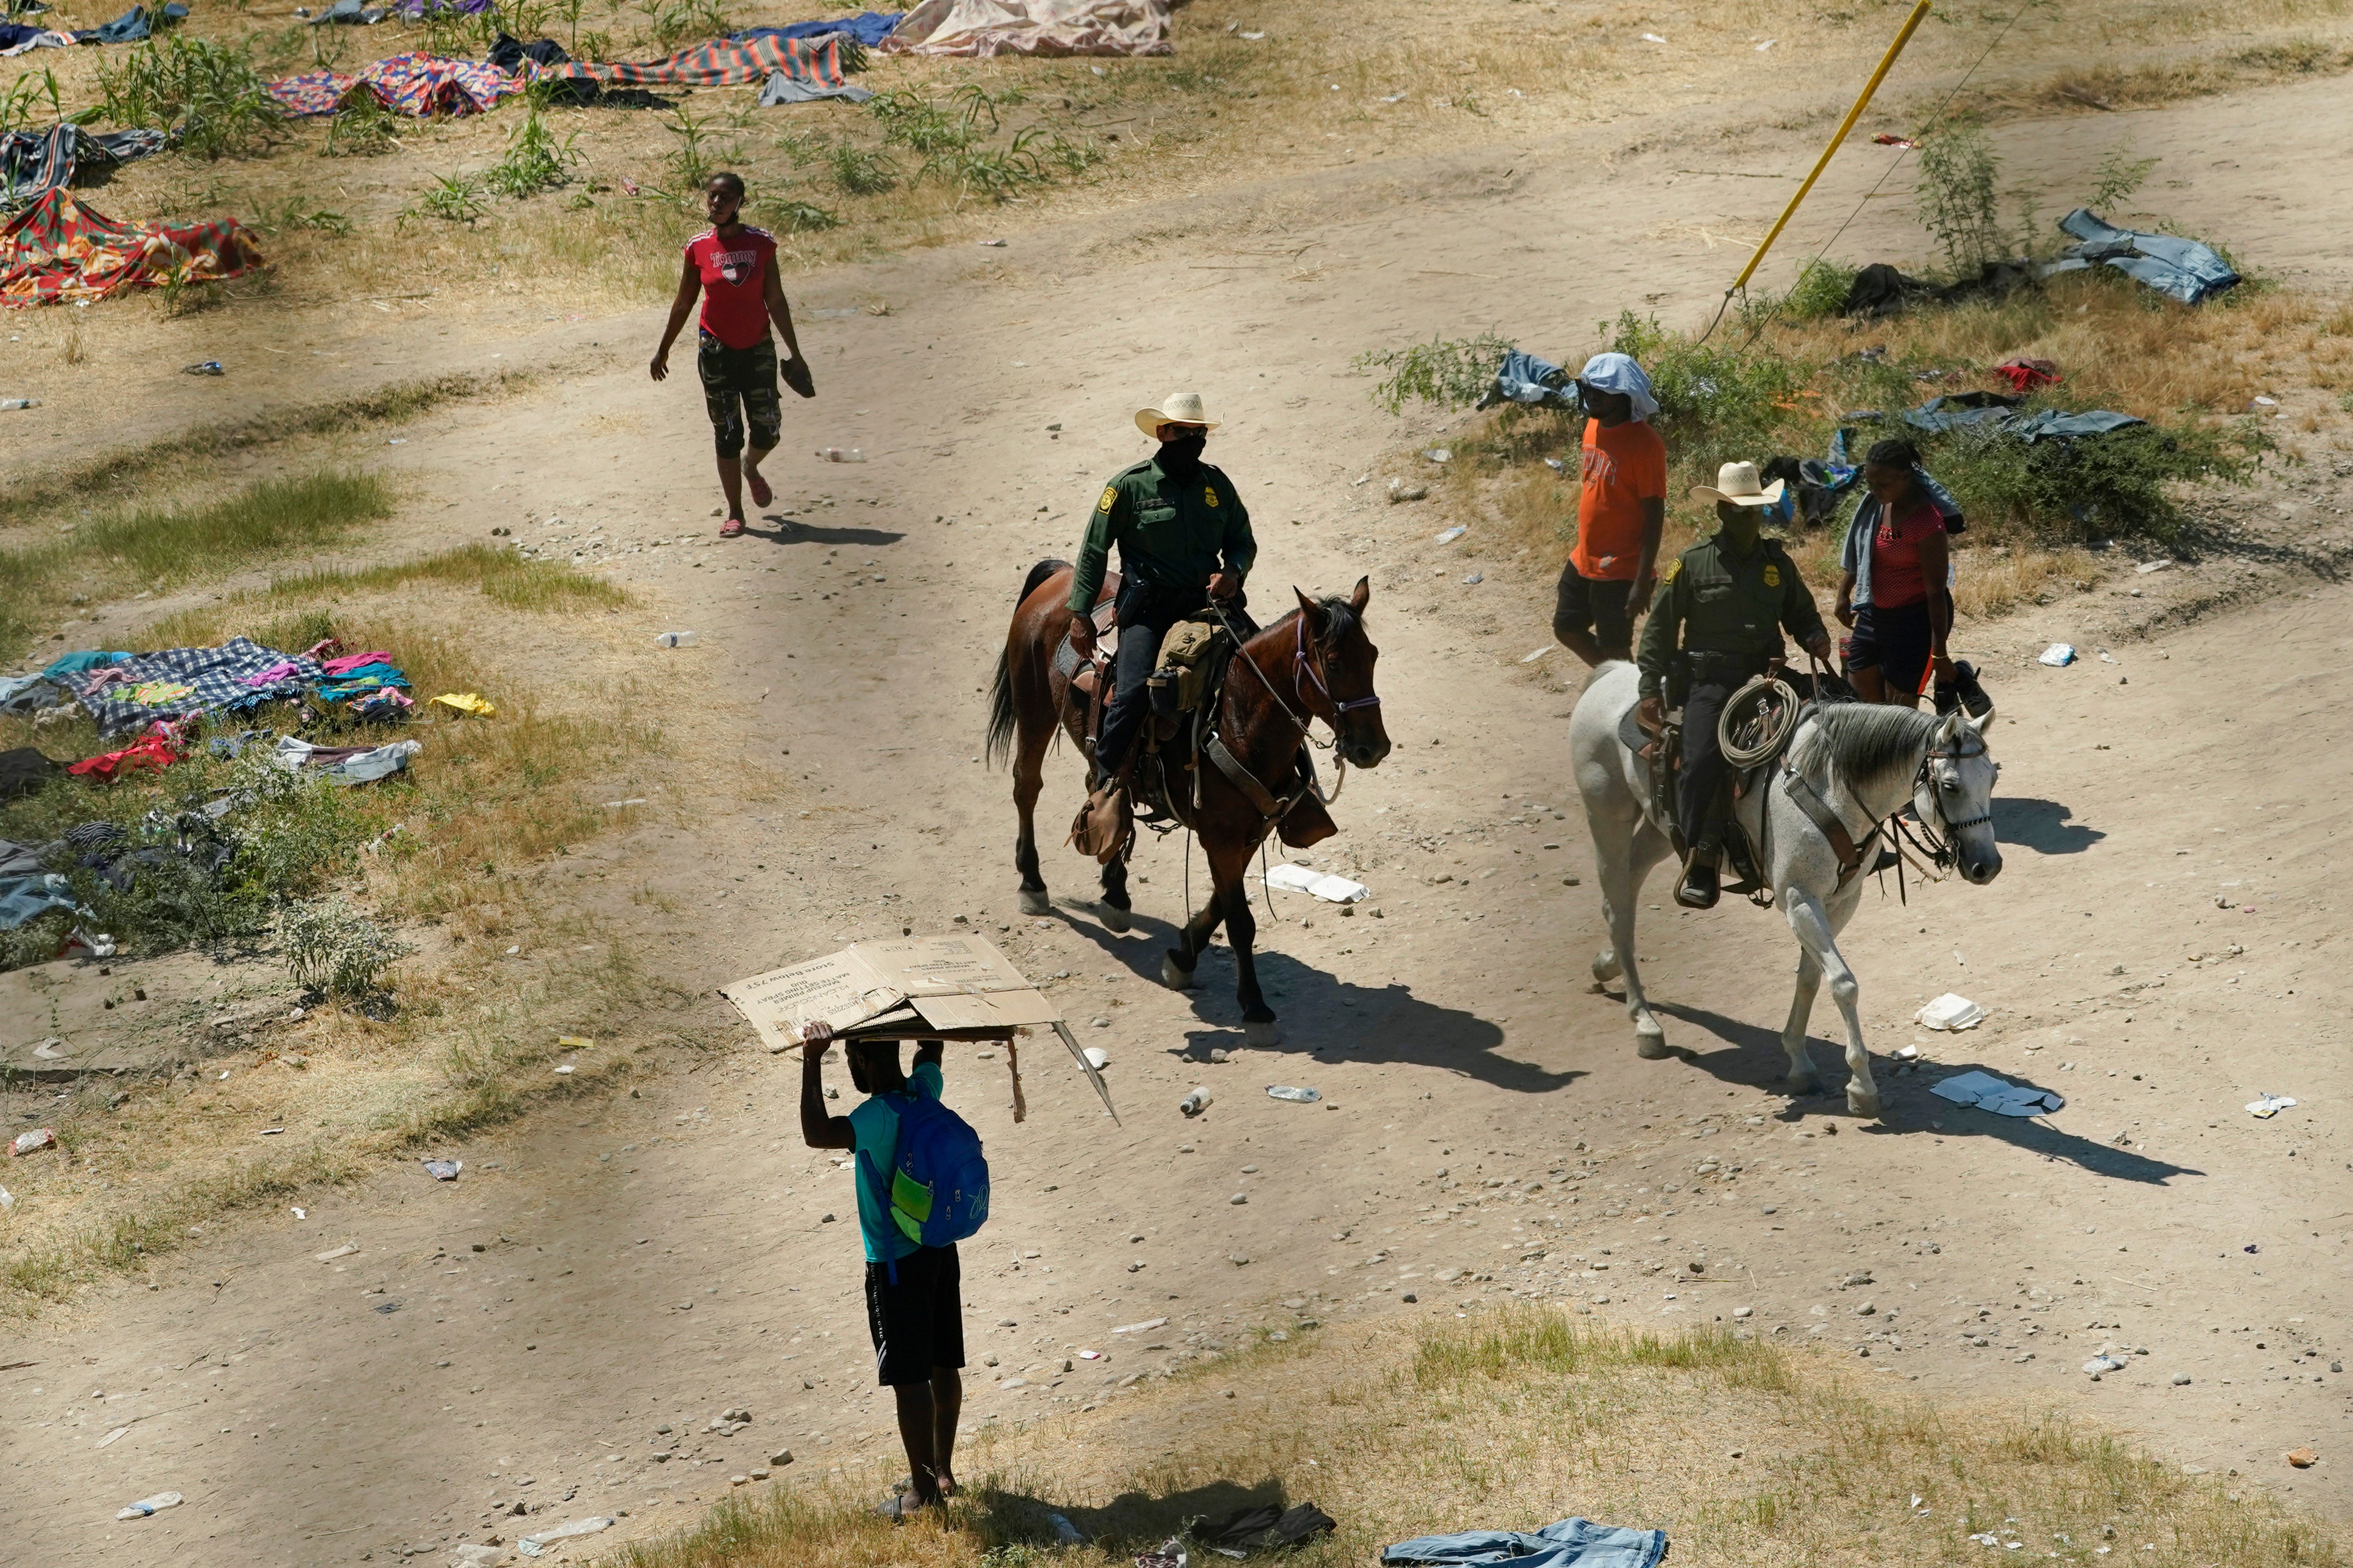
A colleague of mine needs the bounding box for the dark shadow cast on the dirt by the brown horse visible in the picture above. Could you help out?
[1054,901,1586,1093]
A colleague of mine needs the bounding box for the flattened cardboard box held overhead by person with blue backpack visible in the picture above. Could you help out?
[720,936,1061,1051]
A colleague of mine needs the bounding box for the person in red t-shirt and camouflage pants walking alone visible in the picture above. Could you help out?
[652,169,816,538]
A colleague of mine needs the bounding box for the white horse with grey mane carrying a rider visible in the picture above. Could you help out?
[1570,661,2003,1117]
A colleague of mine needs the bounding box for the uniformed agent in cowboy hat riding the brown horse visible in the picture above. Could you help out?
[1070,392,1259,792]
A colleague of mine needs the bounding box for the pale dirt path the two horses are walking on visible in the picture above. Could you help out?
[13,85,2353,1565]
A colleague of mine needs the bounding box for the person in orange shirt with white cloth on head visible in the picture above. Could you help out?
[1553,355,1666,665]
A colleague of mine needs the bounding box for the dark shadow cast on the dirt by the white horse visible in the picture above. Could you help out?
[1664,1004,2205,1187]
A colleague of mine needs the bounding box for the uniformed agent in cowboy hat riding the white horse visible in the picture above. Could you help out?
[1635,463,1831,910]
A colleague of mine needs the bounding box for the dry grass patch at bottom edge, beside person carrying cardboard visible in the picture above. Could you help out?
[588,1305,2346,1568]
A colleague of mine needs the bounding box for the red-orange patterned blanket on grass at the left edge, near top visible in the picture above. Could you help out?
[0,188,261,306]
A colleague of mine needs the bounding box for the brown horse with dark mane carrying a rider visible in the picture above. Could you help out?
[988,559,1388,1046]
